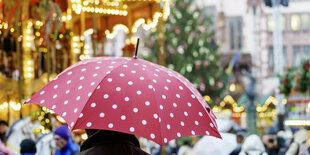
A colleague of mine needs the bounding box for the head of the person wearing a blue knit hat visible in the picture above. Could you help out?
[54,125,70,150]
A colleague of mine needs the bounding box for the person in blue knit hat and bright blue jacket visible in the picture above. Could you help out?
[54,125,79,155]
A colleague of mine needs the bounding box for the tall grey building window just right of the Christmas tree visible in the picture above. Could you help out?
[229,17,242,50]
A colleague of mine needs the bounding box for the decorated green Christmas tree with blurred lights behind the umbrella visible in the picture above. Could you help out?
[145,0,226,104]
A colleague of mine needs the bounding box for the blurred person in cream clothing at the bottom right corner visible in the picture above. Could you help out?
[285,129,310,155]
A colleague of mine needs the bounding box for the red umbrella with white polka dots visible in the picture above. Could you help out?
[26,57,221,145]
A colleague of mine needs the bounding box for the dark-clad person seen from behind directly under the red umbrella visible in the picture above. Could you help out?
[78,129,148,155]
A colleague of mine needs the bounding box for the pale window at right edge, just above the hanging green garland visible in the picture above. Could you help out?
[293,45,310,66]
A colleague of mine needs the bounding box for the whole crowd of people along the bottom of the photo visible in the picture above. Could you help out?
[0,118,310,155]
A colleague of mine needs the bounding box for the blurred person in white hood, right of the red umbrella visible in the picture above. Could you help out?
[239,134,268,155]
